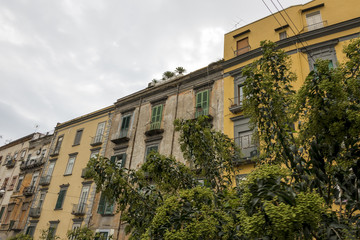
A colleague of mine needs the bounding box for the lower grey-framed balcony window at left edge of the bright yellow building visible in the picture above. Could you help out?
[234,117,258,160]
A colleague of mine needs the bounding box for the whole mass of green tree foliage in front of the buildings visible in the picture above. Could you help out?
[88,40,360,240]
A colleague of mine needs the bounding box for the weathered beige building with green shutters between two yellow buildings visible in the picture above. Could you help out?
[89,62,223,239]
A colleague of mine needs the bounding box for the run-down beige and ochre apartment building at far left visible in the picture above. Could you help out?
[0,133,52,239]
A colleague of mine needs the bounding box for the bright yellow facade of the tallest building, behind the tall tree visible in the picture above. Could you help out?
[224,0,360,174]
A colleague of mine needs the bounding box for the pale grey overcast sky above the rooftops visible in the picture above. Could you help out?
[0,0,308,146]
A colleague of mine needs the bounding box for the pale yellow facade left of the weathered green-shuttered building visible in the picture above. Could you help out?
[33,107,113,239]
